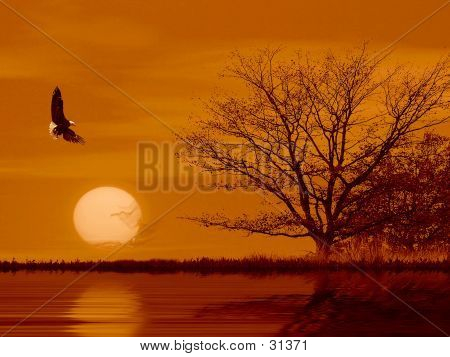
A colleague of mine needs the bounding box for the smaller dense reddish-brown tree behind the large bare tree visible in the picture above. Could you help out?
[359,133,450,252]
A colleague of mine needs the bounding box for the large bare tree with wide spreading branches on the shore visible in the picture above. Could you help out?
[182,48,449,254]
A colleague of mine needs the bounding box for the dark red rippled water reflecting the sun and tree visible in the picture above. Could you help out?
[0,272,450,336]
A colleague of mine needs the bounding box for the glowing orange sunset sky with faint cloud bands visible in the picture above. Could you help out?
[0,0,450,259]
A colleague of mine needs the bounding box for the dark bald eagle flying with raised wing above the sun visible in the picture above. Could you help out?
[49,87,84,144]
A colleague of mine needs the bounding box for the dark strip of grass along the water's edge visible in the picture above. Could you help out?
[0,257,450,274]
